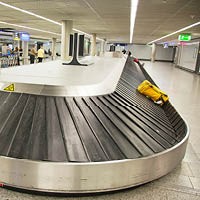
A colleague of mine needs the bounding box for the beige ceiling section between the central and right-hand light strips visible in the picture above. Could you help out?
[134,0,200,43]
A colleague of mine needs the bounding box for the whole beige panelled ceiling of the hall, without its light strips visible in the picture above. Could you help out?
[0,0,200,43]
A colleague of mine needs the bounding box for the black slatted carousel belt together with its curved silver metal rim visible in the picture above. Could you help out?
[0,57,189,193]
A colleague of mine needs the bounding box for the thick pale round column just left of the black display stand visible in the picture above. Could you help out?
[61,20,73,60]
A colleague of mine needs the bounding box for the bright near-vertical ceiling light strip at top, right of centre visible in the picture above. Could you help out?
[130,0,139,43]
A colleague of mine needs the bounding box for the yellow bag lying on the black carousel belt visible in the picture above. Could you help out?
[137,80,169,105]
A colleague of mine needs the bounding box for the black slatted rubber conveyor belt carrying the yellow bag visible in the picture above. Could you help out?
[0,58,186,162]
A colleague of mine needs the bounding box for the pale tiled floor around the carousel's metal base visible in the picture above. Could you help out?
[0,62,200,200]
